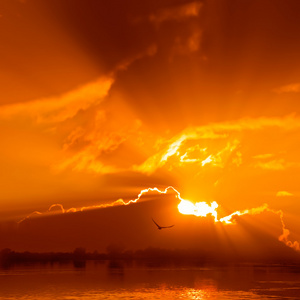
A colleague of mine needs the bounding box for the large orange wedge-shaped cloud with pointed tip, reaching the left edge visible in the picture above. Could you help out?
[0,77,127,174]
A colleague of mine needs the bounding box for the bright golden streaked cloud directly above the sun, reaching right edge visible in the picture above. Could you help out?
[133,116,300,174]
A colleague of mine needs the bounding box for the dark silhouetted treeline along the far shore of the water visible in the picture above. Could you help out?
[0,245,300,268]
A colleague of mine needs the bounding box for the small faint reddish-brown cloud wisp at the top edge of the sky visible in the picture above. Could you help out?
[149,1,203,26]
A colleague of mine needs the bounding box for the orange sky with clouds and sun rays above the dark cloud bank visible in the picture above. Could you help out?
[0,0,300,258]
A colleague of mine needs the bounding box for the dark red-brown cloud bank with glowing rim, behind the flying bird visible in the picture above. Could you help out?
[0,196,299,261]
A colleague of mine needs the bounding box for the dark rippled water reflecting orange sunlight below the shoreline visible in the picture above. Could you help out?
[0,262,300,300]
